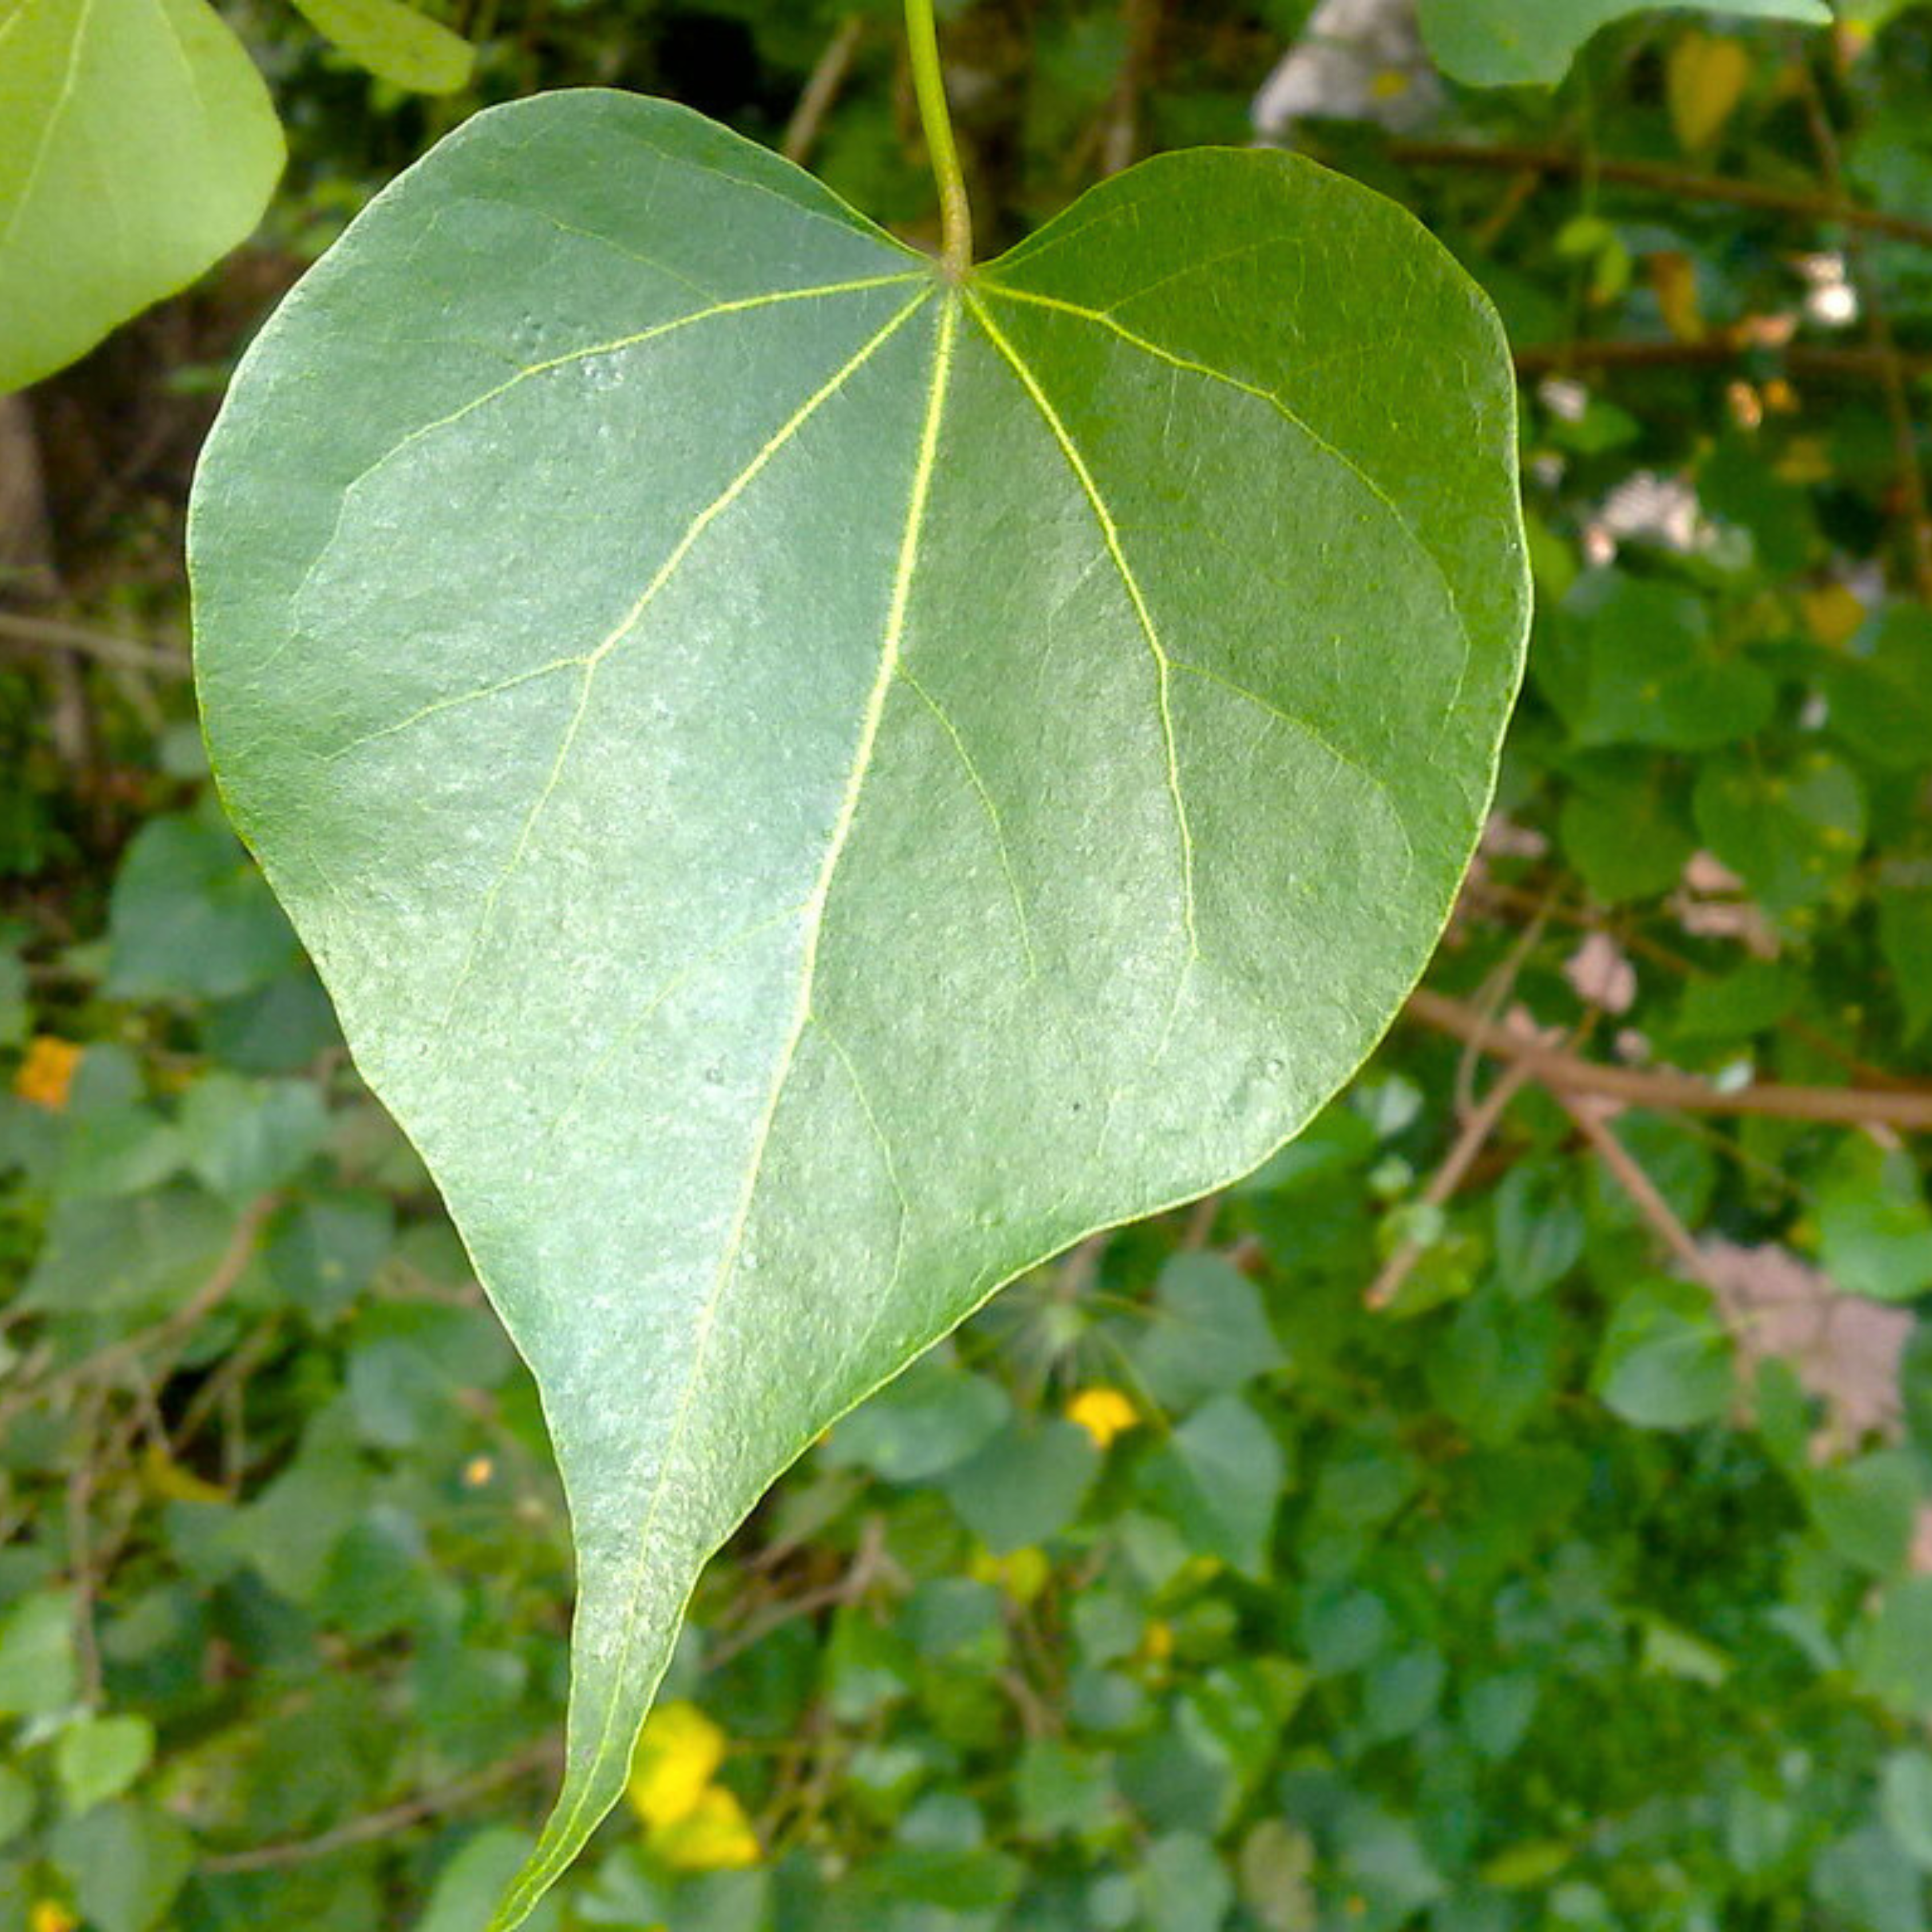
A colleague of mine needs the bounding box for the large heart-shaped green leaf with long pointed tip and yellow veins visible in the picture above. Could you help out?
[191,93,1528,1925]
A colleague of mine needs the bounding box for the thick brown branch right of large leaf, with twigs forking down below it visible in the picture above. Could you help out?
[1402,987,1932,1134]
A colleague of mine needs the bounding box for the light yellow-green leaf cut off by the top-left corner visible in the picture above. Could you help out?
[0,0,282,390]
